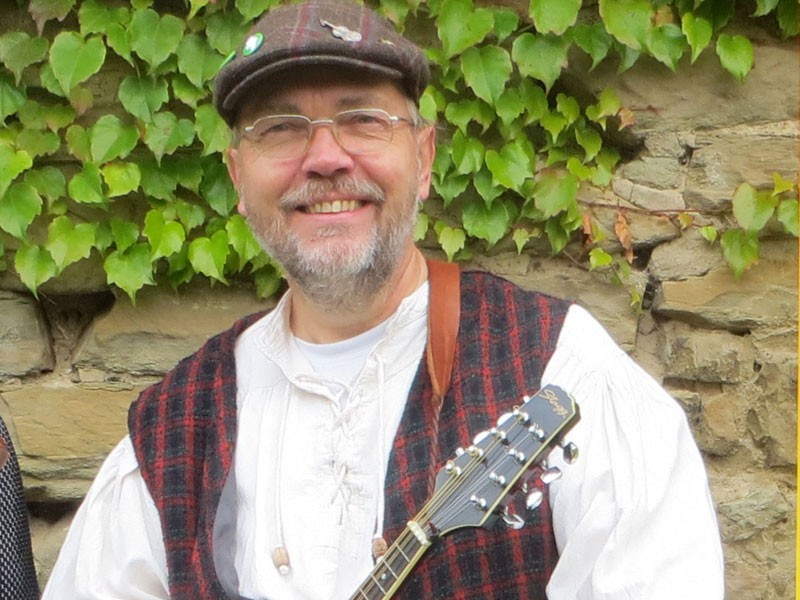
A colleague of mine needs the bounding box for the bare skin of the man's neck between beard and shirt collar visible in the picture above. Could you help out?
[289,245,428,344]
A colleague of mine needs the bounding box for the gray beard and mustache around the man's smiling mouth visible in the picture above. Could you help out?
[240,180,419,312]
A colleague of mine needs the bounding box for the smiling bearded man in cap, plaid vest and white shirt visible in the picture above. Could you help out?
[45,0,723,600]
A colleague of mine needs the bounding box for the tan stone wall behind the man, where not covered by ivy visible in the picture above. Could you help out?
[0,18,800,600]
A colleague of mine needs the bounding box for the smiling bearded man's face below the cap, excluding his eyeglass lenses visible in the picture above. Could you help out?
[228,68,434,304]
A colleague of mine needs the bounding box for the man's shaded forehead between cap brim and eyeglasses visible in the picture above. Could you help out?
[237,67,410,125]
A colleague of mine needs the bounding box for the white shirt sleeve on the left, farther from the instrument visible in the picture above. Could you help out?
[43,437,169,600]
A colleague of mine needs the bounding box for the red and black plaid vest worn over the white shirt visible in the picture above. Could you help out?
[128,272,569,600]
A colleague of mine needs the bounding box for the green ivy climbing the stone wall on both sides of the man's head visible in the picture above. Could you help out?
[0,0,799,300]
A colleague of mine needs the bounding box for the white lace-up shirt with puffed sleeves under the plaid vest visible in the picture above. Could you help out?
[43,286,724,600]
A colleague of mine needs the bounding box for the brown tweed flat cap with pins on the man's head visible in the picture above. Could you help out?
[214,0,430,125]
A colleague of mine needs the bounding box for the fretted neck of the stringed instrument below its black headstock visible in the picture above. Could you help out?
[350,521,431,600]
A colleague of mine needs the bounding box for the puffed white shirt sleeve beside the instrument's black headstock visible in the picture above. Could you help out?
[543,306,724,600]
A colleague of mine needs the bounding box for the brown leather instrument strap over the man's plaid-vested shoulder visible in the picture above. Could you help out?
[426,258,461,415]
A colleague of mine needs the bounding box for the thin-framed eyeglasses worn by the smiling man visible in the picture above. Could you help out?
[242,108,413,158]
